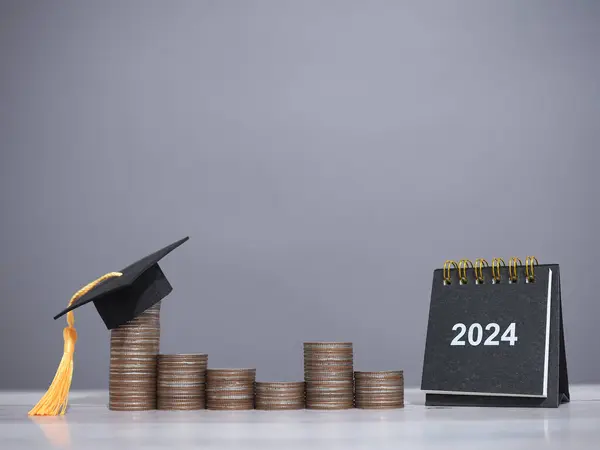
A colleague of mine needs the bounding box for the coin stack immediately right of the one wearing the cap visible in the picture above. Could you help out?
[157,353,208,410]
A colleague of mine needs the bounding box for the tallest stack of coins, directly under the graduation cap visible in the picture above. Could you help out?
[108,303,160,411]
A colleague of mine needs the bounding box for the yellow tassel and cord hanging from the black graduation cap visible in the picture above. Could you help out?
[29,272,122,416]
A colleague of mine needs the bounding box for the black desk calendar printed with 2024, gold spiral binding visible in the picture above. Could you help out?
[421,256,569,407]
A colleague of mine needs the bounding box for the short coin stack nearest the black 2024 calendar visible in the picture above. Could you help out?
[354,370,404,409]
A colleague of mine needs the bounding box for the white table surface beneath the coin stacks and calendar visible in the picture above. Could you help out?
[0,386,600,450]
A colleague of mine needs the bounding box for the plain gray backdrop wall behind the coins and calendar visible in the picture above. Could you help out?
[0,0,600,389]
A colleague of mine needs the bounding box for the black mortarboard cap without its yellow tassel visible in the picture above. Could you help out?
[54,237,189,330]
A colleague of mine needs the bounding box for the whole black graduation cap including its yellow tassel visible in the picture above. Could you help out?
[29,237,189,416]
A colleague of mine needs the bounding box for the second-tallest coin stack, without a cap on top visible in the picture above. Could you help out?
[304,342,354,409]
